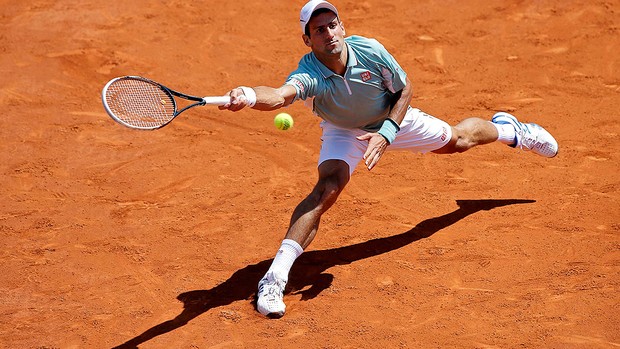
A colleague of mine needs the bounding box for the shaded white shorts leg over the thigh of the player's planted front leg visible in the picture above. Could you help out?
[319,121,368,175]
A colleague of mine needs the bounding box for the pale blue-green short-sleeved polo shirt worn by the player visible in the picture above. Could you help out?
[286,36,407,132]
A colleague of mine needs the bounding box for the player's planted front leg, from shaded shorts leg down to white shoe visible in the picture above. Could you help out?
[257,124,365,317]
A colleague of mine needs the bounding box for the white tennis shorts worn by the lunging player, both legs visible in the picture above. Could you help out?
[319,107,452,174]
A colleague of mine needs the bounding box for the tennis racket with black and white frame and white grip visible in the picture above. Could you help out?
[101,76,230,130]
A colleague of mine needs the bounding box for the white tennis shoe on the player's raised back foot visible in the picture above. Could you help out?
[491,112,559,158]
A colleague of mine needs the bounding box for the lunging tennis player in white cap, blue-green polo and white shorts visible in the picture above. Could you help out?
[220,0,558,317]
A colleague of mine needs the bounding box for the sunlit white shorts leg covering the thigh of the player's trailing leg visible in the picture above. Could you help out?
[388,108,452,153]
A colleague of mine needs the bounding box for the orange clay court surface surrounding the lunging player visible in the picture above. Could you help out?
[0,0,620,349]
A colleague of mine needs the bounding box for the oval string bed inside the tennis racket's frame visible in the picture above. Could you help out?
[106,79,176,128]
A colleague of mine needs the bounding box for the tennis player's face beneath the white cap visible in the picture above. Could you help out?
[304,12,345,55]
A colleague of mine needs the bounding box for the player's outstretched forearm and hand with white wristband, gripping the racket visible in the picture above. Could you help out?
[219,84,297,111]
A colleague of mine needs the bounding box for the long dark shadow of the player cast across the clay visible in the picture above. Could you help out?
[115,199,535,349]
